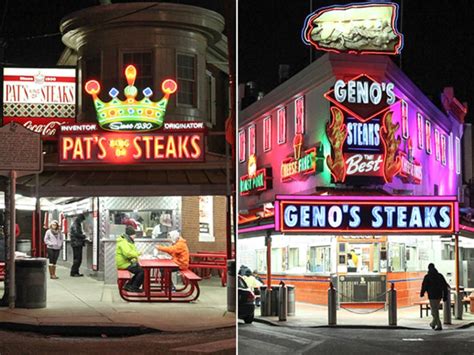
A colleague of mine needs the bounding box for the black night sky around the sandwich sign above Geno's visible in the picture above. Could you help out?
[238,0,474,122]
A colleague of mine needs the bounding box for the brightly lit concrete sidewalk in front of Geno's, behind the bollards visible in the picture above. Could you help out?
[255,302,474,329]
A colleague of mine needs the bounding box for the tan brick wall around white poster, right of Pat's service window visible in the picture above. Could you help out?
[181,196,226,253]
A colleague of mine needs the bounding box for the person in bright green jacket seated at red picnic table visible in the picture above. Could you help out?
[115,226,144,292]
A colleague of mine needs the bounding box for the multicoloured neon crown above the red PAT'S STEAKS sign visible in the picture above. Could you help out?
[85,65,178,132]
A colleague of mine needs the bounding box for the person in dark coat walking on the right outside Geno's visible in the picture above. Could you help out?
[420,263,450,330]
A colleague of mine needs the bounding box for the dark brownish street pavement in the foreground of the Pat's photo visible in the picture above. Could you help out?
[0,326,236,355]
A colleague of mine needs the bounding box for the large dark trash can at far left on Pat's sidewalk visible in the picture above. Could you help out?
[15,258,48,308]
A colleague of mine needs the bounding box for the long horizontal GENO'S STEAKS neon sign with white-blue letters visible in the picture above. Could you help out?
[275,195,459,234]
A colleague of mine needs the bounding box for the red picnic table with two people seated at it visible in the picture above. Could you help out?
[117,259,201,302]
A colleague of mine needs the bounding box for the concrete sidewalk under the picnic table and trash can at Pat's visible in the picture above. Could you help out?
[0,267,236,332]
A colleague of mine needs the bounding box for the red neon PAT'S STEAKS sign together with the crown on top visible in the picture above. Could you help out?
[59,65,206,164]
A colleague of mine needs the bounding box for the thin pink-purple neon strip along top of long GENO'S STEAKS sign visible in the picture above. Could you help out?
[275,195,457,202]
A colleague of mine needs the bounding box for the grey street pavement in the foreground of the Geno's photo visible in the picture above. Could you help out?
[238,321,474,355]
